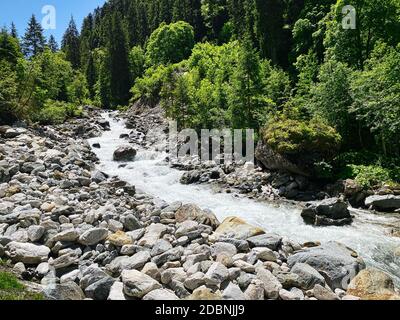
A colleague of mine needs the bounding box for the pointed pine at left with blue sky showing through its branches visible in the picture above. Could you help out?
[22,15,46,57]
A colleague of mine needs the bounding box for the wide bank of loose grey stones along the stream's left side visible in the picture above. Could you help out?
[0,111,399,300]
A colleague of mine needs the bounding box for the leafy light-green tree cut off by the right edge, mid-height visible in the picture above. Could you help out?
[351,45,400,155]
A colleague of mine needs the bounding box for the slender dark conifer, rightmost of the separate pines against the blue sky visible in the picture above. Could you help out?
[61,17,81,69]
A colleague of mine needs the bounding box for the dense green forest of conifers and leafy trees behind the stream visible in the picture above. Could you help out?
[0,0,400,188]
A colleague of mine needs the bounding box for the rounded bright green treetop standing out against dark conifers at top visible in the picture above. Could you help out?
[146,21,194,65]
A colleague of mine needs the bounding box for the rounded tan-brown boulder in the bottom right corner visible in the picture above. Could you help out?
[347,268,400,300]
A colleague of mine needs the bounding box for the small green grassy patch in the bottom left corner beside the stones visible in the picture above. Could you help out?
[0,271,44,300]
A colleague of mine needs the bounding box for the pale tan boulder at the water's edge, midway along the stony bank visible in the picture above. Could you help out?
[215,217,265,240]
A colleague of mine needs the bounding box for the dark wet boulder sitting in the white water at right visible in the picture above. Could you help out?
[301,198,352,226]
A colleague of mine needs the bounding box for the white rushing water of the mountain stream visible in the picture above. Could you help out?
[89,114,400,285]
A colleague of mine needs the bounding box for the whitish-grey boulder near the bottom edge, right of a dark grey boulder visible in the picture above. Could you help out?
[121,270,162,298]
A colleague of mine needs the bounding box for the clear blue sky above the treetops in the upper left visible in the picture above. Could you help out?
[0,0,106,43]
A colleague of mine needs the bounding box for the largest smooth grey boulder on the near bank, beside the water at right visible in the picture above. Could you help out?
[287,241,365,289]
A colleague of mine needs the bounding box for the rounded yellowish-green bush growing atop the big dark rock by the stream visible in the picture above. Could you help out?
[262,119,341,158]
